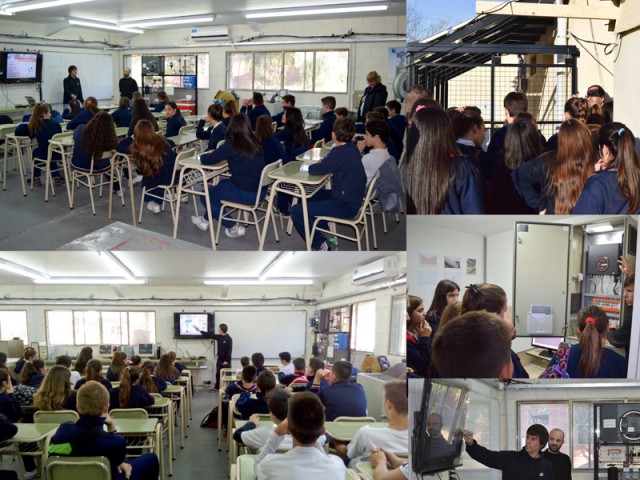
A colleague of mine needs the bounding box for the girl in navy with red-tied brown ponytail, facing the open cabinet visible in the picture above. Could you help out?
[567,306,627,378]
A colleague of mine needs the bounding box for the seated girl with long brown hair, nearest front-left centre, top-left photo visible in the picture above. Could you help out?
[130,120,178,213]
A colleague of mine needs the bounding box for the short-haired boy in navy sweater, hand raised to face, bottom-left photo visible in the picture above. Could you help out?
[314,360,367,422]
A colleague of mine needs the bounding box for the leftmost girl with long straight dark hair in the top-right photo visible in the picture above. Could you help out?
[406,107,484,215]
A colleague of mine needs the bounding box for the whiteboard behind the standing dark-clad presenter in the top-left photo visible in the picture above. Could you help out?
[42,51,115,104]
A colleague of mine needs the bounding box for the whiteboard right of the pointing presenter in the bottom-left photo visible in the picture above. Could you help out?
[215,310,307,358]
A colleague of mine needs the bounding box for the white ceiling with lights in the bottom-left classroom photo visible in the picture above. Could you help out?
[0,251,396,284]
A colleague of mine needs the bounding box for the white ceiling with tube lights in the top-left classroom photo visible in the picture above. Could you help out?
[0,0,406,28]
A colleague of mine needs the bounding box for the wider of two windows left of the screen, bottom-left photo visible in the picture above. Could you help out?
[45,310,156,345]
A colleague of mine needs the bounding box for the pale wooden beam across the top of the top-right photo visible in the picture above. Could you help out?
[476,0,619,20]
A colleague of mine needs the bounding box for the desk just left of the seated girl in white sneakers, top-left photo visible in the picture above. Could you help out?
[173,155,229,250]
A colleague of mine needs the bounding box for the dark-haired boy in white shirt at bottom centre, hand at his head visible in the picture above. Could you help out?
[254,392,346,480]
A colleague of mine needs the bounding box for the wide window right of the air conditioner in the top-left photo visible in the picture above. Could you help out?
[227,50,349,93]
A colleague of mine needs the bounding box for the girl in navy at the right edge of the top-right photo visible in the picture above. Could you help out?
[571,122,640,215]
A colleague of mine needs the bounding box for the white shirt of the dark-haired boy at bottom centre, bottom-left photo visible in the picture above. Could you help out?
[254,432,347,480]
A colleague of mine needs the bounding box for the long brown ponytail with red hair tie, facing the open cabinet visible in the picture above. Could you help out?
[578,306,609,378]
